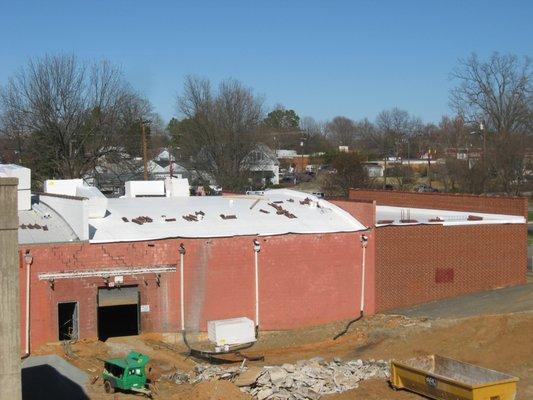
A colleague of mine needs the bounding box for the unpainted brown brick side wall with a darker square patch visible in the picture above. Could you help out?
[375,224,527,311]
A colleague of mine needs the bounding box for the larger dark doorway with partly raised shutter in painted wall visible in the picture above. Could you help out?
[98,286,139,341]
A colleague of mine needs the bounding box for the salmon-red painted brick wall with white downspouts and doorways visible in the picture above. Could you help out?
[20,233,374,348]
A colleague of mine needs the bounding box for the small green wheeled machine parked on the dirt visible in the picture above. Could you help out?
[102,351,152,397]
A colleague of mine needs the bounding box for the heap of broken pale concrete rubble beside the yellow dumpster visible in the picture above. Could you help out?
[166,357,389,400]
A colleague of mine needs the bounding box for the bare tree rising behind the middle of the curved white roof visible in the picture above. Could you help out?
[178,76,264,189]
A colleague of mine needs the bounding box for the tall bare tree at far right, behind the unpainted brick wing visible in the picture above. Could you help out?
[450,53,533,194]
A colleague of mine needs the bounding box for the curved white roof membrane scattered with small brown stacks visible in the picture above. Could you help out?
[89,189,366,243]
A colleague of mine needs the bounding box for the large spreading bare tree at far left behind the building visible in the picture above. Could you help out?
[0,55,150,184]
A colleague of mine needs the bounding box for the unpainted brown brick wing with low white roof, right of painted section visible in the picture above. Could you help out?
[348,189,528,311]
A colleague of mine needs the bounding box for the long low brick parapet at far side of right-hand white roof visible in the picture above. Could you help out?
[349,189,527,218]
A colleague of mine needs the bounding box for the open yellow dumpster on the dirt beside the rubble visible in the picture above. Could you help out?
[390,355,518,400]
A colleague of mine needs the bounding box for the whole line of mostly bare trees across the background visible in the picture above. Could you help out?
[0,53,533,194]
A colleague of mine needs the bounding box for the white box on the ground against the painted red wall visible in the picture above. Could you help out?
[207,317,256,346]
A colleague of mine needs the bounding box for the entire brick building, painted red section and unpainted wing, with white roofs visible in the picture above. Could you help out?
[7,164,527,350]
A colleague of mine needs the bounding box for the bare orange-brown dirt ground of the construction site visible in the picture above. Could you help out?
[35,277,533,400]
